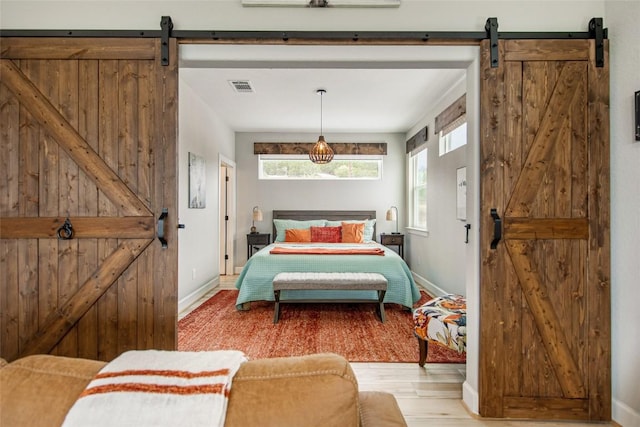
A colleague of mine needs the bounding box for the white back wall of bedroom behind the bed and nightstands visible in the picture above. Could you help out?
[235,132,405,267]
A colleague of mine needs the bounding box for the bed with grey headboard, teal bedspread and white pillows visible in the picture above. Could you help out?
[236,210,420,310]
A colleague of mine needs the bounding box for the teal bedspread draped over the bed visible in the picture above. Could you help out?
[236,243,420,309]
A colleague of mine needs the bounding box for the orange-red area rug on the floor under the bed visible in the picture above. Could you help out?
[178,290,465,363]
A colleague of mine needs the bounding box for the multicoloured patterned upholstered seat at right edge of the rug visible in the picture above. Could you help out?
[413,295,467,366]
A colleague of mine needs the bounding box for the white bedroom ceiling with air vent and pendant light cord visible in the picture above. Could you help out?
[180,45,469,134]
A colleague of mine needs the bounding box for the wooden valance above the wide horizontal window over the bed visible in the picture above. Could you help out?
[253,142,387,156]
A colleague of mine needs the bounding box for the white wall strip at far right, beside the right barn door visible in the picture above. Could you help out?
[605,1,640,427]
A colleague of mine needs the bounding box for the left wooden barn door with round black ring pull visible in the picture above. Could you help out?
[0,38,177,360]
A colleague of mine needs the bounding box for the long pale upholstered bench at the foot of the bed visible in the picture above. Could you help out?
[273,272,387,323]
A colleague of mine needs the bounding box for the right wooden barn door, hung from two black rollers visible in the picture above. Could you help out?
[479,40,611,420]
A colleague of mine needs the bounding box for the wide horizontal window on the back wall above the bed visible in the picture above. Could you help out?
[258,154,382,180]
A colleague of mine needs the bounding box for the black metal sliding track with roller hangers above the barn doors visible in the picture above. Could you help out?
[0,16,608,68]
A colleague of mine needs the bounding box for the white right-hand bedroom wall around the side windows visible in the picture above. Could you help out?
[405,79,467,295]
